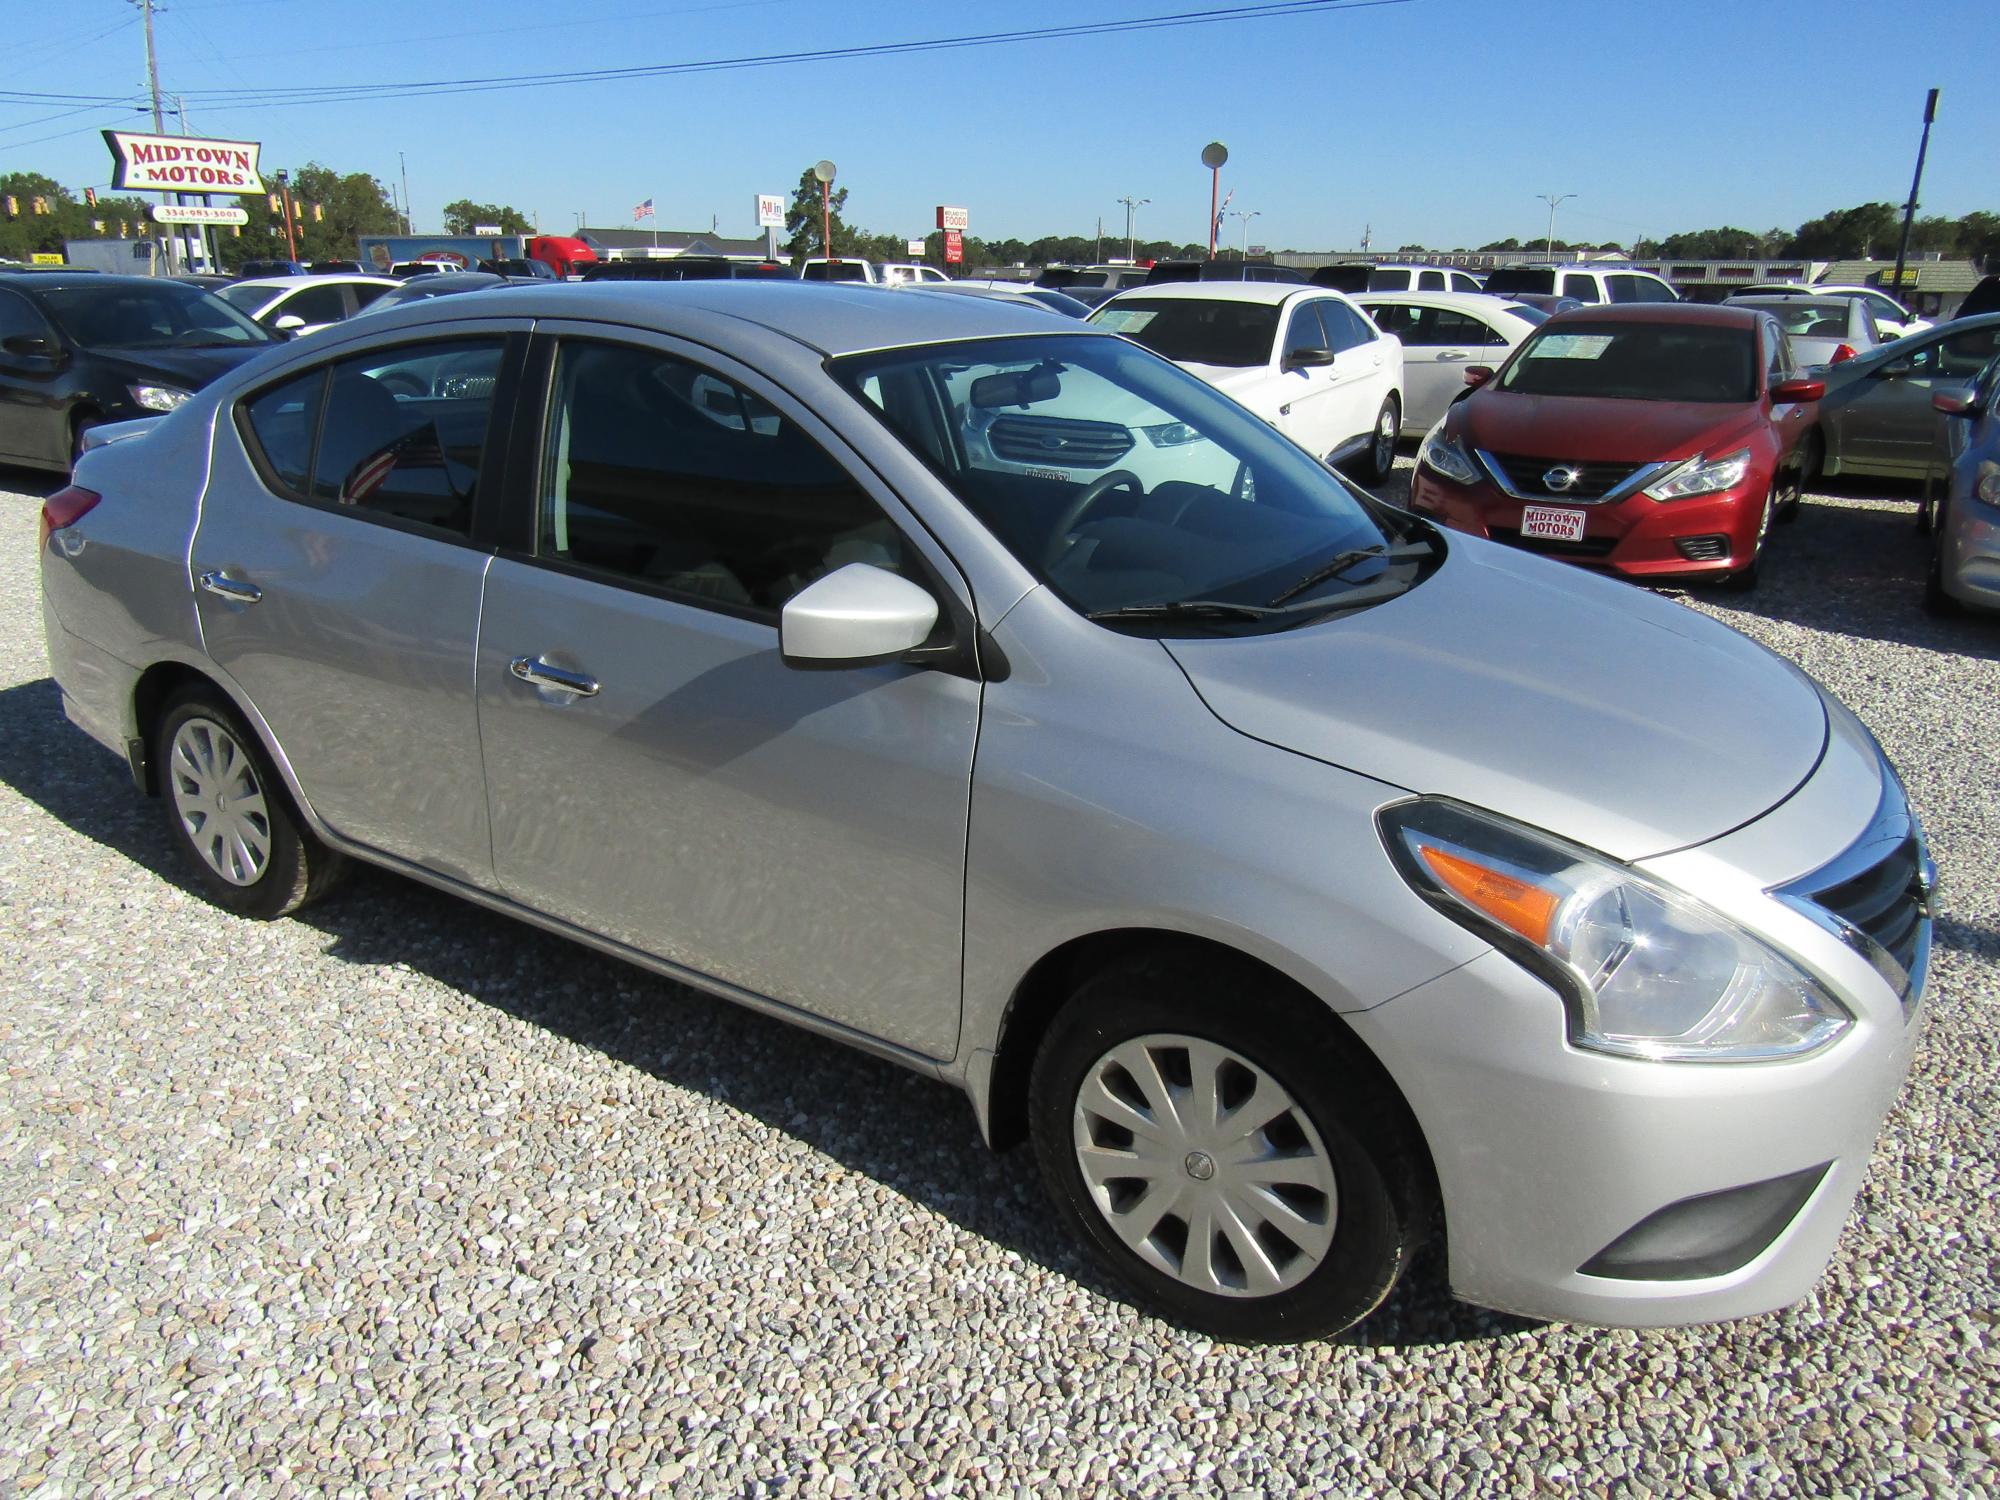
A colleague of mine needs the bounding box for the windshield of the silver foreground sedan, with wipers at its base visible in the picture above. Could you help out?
[830,334,1442,630]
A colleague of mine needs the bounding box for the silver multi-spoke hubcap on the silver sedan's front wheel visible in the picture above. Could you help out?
[1072,1032,1338,1296]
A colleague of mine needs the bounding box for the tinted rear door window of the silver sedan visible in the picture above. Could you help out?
[308,338,502,536]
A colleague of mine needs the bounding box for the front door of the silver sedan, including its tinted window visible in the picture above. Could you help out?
[478,324,980,1058]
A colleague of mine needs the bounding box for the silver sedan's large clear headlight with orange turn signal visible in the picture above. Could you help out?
[1380,798,1854,1062]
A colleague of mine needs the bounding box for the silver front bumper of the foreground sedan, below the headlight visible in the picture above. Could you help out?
[1346,728,1930,1326]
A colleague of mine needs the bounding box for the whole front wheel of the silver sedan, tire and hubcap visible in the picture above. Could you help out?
[1030,958,1428,1342]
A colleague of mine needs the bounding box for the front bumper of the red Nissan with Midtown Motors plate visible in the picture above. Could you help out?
[1410,466,1770,580]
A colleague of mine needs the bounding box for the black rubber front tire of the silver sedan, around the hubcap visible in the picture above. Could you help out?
[1028,952,1432,1344]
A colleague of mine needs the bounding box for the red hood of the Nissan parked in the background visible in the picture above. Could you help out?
[1448,390,1764,464]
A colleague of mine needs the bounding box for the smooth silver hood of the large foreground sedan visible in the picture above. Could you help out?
[1162,536,1828,860]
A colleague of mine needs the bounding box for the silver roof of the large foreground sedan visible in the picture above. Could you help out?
[370,278,1114,358]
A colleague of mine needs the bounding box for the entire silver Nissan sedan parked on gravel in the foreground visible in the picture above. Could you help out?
[42,282,1932,1340]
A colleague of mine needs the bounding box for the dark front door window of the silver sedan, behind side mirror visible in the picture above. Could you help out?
[536,342,914,620]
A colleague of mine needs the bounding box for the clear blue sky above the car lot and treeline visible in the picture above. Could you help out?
[0,0,2000,250]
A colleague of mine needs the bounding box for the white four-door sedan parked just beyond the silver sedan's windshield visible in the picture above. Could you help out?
[1090,282,1402,482]
